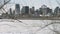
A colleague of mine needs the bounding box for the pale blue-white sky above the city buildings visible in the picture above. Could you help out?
[0,0,60,11]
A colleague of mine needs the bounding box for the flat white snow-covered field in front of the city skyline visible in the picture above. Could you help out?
[0,19,59,34]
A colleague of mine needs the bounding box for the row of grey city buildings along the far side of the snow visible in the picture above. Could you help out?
[1,4,60,19]
